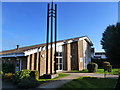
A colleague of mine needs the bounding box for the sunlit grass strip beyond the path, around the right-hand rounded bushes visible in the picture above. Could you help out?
[72,69,120,75]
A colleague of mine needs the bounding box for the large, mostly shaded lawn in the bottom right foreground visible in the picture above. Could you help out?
[60,77,117,88]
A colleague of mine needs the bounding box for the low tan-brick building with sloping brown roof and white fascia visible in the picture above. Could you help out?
[0,36,93,75]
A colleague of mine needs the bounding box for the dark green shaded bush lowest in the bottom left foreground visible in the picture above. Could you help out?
[18,77,39,89]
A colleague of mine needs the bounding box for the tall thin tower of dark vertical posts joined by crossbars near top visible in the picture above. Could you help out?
[46,1,57,75]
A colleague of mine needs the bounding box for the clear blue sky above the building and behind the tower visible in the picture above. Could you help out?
[2,2,118,52]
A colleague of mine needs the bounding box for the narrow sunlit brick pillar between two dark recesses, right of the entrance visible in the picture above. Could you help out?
[67,43,71,71]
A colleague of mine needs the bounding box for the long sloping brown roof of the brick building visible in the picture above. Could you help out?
[0,36,92,54]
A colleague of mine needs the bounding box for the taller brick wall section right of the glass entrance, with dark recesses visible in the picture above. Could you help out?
[63,40,91,71]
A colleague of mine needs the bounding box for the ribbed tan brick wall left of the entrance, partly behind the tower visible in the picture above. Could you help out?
[27,49,54,76]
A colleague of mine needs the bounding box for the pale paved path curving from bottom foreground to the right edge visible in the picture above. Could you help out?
[38,73,118,88]
